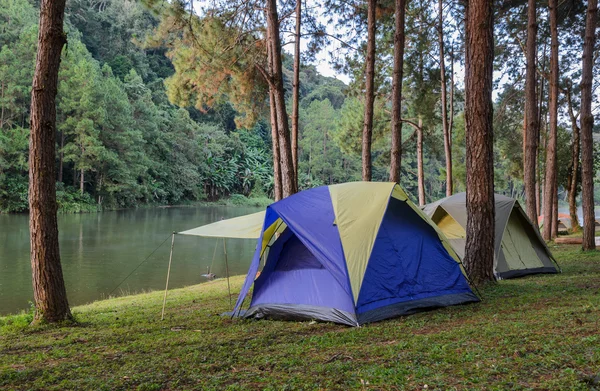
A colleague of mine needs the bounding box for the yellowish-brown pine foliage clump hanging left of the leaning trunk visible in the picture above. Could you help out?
[149,10,266,127]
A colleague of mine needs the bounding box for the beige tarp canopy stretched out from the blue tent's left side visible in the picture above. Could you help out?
[178,211,265,239]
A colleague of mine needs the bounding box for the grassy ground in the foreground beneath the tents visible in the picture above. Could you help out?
[0,246,600,390]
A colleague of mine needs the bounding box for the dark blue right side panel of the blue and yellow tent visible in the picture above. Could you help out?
[356,198,479,323]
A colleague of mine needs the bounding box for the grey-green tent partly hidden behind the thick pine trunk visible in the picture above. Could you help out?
[423,193,559,279]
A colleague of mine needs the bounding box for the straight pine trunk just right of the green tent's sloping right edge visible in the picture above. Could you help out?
[542,0,559,240]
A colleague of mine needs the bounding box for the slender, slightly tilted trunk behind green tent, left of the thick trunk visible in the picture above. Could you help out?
[438,0,452,197]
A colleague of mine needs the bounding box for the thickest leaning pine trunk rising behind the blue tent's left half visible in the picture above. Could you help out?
[267,0,298,198]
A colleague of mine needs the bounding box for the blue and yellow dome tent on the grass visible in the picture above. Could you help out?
[234,182,479,326]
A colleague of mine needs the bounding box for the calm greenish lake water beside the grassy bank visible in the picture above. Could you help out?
[0,206,260,314]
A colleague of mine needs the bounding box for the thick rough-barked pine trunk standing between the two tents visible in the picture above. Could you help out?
[463,0,494,285]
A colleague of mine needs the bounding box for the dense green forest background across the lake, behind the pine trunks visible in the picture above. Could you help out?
[0,0,600,215]
